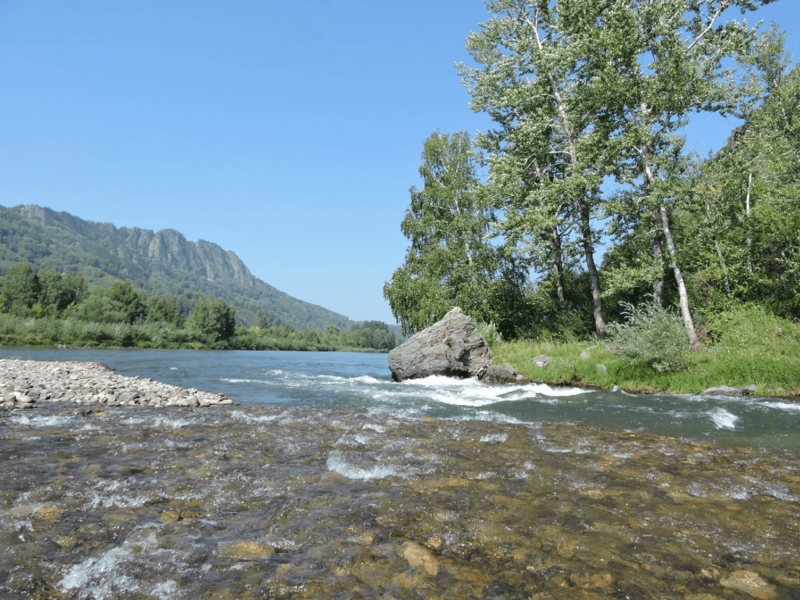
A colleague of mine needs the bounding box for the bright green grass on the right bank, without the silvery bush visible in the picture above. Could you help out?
[493,307,800,397]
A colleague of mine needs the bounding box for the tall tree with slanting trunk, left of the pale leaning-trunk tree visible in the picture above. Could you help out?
[459,0,606,338]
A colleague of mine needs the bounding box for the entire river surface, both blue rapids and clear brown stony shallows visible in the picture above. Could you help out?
[0,349,800,600]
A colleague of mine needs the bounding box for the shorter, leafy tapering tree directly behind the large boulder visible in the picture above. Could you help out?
[383,131,515,335]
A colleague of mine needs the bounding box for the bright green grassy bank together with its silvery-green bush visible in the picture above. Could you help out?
[492,305,800,397]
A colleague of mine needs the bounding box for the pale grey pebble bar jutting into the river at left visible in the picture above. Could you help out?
[0,360,233,409]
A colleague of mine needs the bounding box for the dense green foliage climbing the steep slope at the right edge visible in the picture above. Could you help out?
[677,65,800,319]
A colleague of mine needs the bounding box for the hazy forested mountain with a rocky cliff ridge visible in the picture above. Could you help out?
[0,205,352,329]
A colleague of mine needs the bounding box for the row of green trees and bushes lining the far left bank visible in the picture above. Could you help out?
[0,265,397,352]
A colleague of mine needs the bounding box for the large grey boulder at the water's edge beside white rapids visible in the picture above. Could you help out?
[389,307,492,381]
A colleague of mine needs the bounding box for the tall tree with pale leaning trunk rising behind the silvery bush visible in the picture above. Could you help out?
[581,0,781,347]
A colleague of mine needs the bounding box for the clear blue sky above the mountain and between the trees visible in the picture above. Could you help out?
[0,0,800,322]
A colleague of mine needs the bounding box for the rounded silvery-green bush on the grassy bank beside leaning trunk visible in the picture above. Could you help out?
[608,302,690,372]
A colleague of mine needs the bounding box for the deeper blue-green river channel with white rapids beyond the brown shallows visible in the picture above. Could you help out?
[0,349,800,448]
